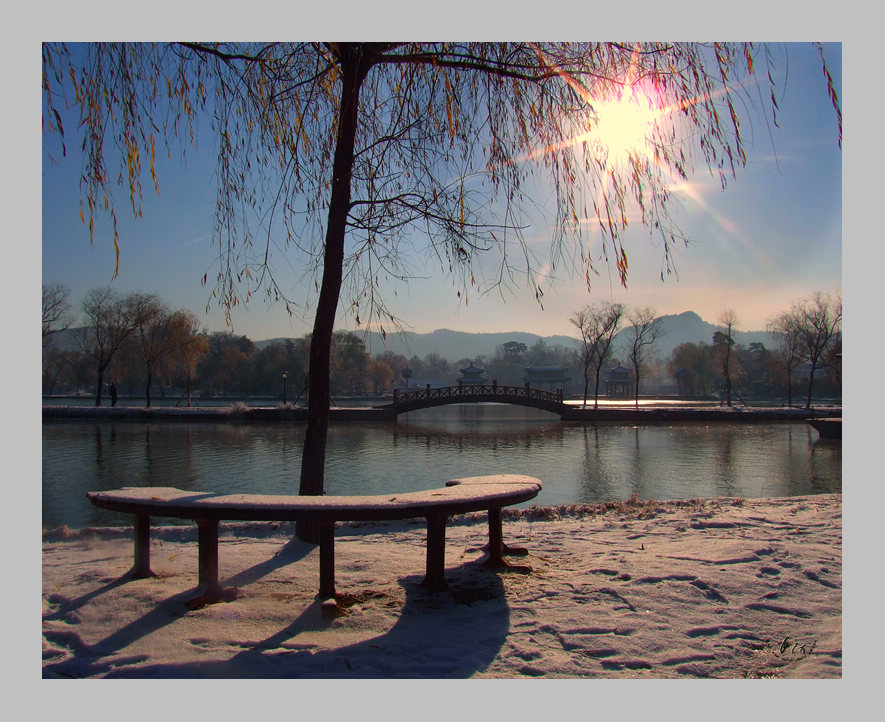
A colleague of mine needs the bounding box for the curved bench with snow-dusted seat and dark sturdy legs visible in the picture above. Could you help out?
[86,474,541,607]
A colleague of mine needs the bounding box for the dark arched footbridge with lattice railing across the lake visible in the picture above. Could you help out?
[380,381,567,416]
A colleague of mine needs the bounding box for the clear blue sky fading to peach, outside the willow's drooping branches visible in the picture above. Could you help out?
[41,43,842,340]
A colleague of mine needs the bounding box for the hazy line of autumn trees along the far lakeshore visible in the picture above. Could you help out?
[42,283,842,408]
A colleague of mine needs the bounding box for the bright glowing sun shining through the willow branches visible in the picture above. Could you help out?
[588,87,662,162]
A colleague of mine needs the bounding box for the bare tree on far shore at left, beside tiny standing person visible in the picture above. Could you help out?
[78,288,136,406]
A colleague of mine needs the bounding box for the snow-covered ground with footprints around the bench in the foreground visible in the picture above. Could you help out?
[43,495,842,679]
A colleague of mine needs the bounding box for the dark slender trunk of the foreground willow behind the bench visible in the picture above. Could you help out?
[295,53,364,543]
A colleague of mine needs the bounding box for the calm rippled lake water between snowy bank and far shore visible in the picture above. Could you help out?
[42,404,842,528]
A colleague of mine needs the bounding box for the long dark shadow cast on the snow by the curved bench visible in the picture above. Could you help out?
[43,540,510,679]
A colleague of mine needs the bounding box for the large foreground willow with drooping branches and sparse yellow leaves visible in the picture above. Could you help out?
[43,43,841,528]
